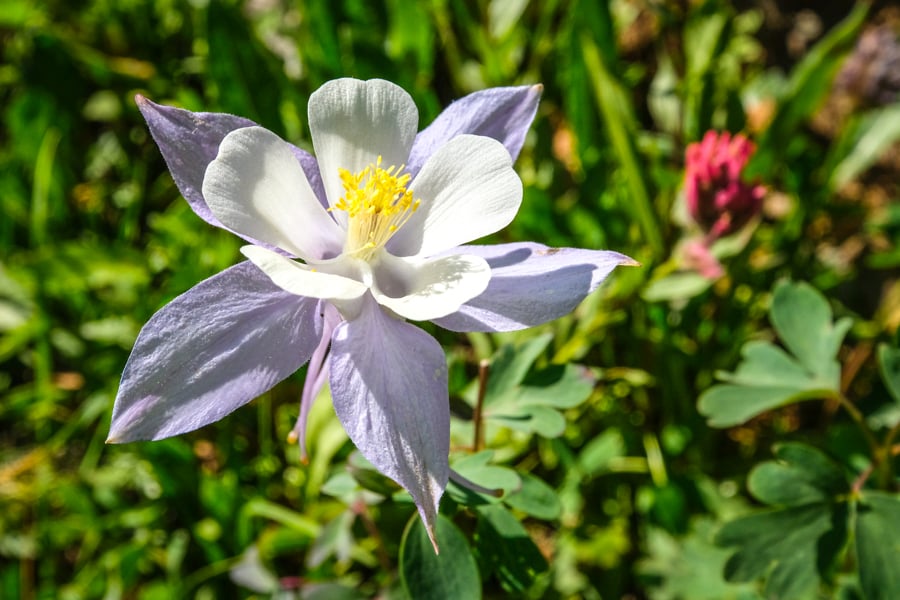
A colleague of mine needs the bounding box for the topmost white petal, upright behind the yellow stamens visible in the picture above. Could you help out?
[309,79,419,223]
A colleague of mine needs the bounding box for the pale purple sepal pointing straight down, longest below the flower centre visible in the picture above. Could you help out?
[330,298,450,543]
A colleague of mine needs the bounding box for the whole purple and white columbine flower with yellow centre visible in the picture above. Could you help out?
[109,79,634,548]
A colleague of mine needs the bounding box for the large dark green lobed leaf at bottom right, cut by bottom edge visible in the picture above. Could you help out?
[716,503,847,599]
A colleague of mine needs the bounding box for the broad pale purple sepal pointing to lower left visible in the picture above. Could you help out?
[107,262,322,443]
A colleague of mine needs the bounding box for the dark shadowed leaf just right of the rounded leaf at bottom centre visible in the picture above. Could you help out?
[475,505,548,593]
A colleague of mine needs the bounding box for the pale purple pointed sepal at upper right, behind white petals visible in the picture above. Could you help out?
[406,85,544,177]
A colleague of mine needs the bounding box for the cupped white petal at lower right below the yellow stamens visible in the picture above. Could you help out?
[372,252,491,321]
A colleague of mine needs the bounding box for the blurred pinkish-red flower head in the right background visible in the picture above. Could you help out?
[684,131,765,242]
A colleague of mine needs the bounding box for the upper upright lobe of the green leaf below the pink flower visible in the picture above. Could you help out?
[770,282,852,380]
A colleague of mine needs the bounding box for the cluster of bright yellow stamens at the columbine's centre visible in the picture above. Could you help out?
[332,156,421,260]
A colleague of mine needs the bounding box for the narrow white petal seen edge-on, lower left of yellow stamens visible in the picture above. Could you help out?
[241,246,368,301]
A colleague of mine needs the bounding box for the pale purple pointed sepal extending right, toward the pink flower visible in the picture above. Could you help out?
[434,242,638,331]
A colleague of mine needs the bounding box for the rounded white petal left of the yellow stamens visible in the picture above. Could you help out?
[203,127,344,259]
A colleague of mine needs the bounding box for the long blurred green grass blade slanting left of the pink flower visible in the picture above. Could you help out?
[581,36,664,258]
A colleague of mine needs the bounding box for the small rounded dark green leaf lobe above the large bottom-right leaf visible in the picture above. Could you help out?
[747,443,850,506]
